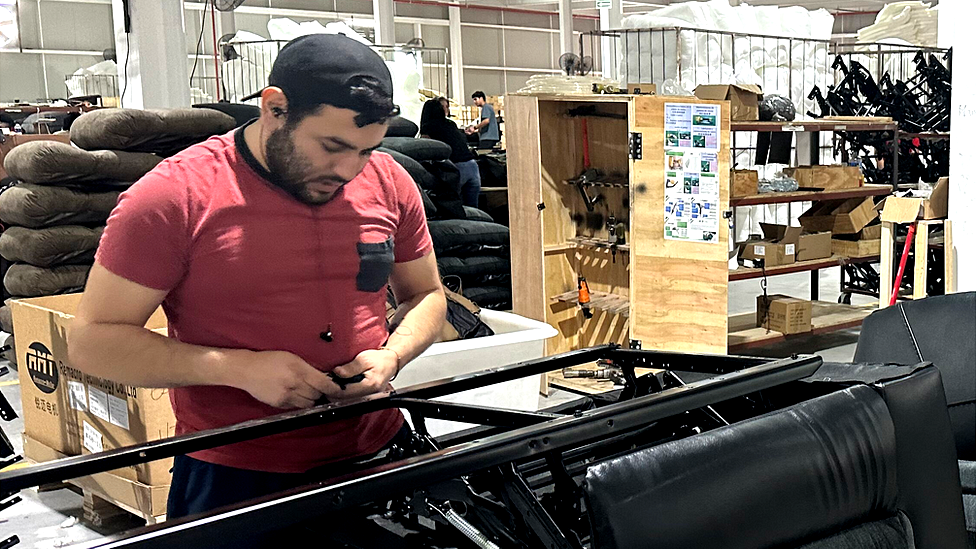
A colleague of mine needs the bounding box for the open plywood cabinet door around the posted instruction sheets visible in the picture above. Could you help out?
[629,96,730,354]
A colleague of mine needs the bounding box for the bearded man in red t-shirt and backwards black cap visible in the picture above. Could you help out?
[68,35,446,518]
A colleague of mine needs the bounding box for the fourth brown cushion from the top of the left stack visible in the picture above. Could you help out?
[0,225,103,266]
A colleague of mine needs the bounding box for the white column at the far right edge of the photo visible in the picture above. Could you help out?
[939,0,976,292]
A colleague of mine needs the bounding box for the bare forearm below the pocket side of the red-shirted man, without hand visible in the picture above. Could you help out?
[385,288,447,368]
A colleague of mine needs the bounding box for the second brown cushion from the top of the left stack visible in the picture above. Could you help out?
[3,141,162,186]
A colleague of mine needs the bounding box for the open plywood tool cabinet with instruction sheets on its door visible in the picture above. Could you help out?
[505,95,730,354]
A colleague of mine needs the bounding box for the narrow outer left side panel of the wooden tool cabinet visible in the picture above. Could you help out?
[506,97,546,321]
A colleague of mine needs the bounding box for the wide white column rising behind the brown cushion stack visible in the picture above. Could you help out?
[112,0,190,109]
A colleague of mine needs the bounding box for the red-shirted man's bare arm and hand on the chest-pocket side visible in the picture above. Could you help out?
[334,253,447,398]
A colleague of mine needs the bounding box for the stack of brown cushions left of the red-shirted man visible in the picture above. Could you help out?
[0,109,235,333]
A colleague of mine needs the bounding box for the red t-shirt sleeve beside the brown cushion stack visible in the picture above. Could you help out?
[95,164,190,290]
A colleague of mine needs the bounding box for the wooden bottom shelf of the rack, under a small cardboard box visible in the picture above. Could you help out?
[728,301,876,352]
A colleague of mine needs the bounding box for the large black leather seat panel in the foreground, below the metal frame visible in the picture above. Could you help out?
[585,386,900,549]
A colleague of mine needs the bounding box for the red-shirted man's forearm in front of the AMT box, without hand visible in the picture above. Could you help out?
[68,324,240,387]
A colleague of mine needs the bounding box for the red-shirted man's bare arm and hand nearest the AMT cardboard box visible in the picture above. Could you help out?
[68,263,340,408]
